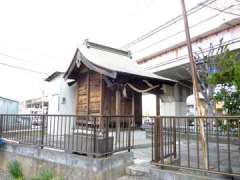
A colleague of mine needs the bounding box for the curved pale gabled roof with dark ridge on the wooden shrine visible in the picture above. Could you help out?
[64,41,176,83]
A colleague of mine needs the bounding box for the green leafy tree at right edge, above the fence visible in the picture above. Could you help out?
[209,47,240,115]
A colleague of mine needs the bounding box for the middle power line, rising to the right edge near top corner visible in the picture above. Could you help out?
[132,4,240,54]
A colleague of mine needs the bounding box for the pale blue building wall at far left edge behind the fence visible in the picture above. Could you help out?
[0,97,19,114]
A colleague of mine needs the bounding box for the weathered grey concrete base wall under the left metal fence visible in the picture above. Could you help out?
[0,144,133,180]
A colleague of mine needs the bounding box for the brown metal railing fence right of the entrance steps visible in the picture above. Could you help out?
[151,116,240,176]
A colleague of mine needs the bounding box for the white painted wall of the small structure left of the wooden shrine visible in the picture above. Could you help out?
[47,77,76,135]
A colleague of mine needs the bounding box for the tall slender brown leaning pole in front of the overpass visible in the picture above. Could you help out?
[181,0,208,169]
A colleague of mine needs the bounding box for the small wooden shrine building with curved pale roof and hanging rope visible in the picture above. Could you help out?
[63,40,175,126]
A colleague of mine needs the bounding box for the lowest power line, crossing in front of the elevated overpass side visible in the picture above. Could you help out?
[146,37,240,70]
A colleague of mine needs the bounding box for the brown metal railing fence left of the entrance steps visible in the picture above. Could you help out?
[0,114,134,156]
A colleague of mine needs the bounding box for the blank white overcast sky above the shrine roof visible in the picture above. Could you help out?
[0,0,229,101]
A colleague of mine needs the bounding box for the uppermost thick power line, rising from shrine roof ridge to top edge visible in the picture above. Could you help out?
[122,0,216,48]
